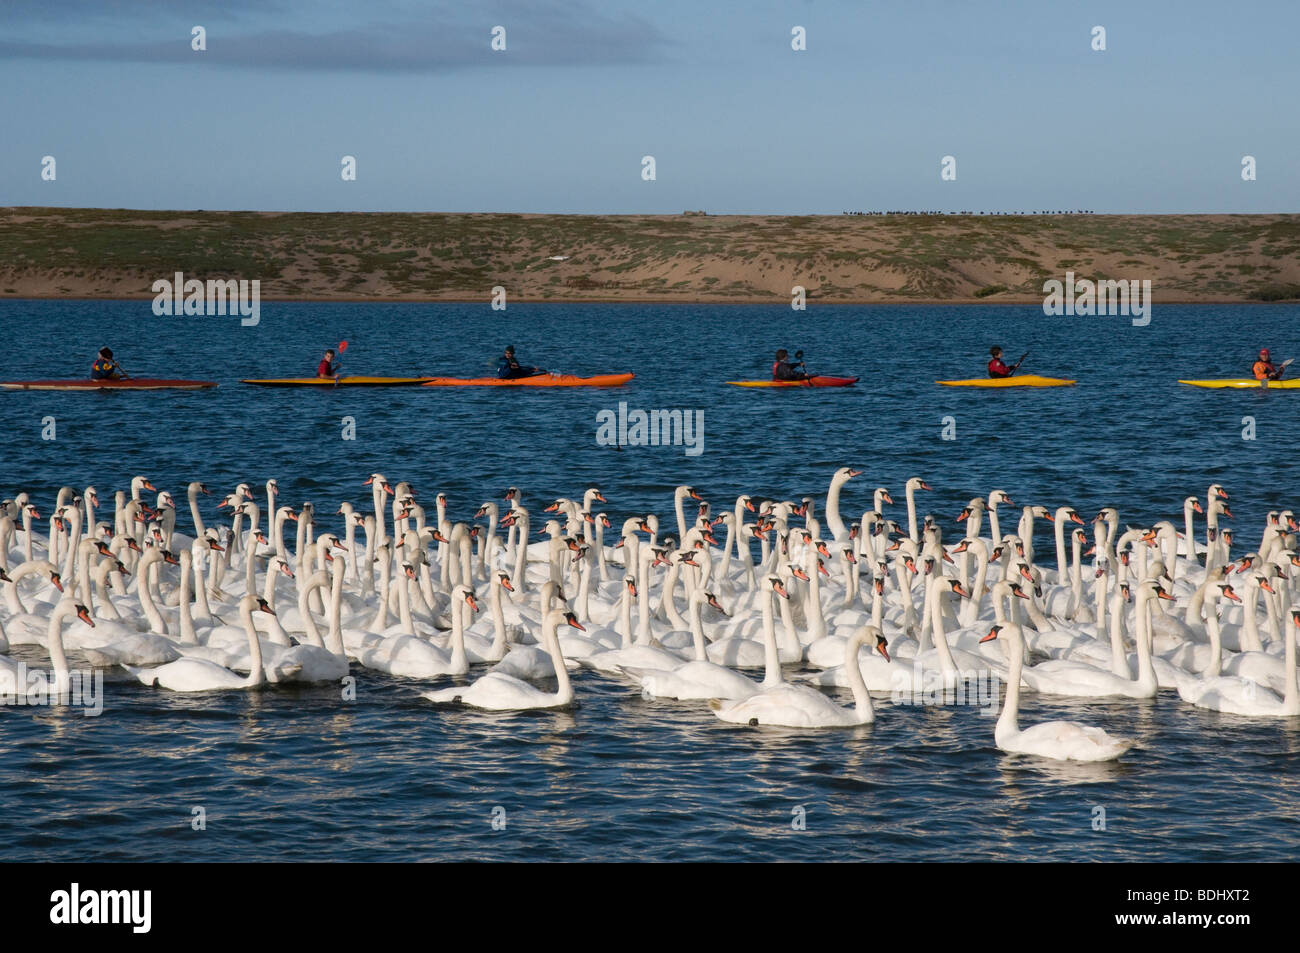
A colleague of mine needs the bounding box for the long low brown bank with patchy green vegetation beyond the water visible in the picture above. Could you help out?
[0,208,1300,303]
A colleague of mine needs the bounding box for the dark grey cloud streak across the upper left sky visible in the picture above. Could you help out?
[0,0,670,73]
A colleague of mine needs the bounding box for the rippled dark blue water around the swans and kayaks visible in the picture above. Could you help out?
[0,302,1300,861]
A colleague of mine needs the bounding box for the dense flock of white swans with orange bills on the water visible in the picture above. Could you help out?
[0,467,1300,761]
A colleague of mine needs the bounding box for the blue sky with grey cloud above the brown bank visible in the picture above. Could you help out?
[0,0,1300,215]
